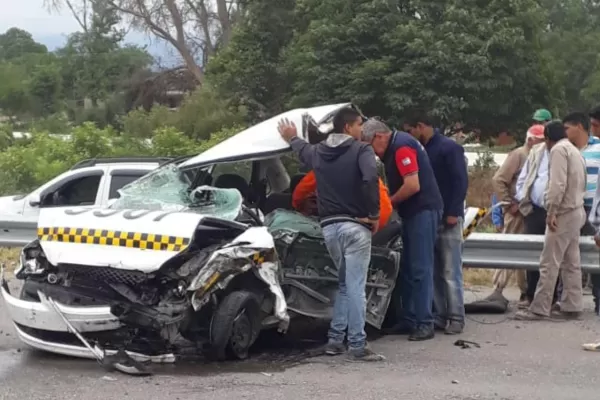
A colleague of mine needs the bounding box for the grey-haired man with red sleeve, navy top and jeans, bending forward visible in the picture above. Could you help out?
[362,120,443,341]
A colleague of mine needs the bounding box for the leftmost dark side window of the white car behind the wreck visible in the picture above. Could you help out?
[41,175,102,207]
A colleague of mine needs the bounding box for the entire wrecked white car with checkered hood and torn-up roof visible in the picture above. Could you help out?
[2,104,402,362]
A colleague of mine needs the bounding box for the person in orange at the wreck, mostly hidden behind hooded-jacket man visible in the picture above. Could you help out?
[292,171,392,230]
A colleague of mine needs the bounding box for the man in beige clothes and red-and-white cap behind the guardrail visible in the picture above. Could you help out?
[490,124,544,302]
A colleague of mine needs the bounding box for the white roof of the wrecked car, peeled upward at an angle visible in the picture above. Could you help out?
[180,103,360,169]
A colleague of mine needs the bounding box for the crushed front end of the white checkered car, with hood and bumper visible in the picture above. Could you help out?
[1,180,289,362]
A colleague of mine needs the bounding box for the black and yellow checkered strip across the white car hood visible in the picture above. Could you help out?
[38,227,190,251]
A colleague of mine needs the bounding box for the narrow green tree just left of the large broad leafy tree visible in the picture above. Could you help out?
[207,0,296,123]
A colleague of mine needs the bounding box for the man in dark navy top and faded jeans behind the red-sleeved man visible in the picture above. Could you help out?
[404,112,469,335]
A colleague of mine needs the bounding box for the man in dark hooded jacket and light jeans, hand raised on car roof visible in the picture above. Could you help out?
[279,108,384,361]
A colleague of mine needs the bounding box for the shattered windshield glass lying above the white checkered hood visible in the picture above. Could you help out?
[109,164,242,220]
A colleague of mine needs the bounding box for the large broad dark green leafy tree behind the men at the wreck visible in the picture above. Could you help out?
[287,0,555,132]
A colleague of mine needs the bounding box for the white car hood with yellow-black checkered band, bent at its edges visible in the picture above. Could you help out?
[37,208,204,272]
